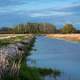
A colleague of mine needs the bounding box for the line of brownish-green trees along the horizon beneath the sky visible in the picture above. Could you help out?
[0,23,80,34]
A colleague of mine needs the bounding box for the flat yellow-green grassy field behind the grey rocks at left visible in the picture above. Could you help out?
[0,34,31,47]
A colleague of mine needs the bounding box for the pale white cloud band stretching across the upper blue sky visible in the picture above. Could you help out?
[0,0,80,17]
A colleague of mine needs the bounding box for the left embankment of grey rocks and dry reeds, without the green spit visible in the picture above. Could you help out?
[0,35,35,80]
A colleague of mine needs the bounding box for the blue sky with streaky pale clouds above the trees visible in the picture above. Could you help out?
[0,0,80,29]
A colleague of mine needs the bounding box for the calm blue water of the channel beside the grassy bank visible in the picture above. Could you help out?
[27,36,80,80]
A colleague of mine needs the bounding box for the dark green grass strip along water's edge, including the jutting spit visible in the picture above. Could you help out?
[21,36,61,80]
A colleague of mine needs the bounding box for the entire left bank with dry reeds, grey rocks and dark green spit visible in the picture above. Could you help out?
[0,35,61,80]
